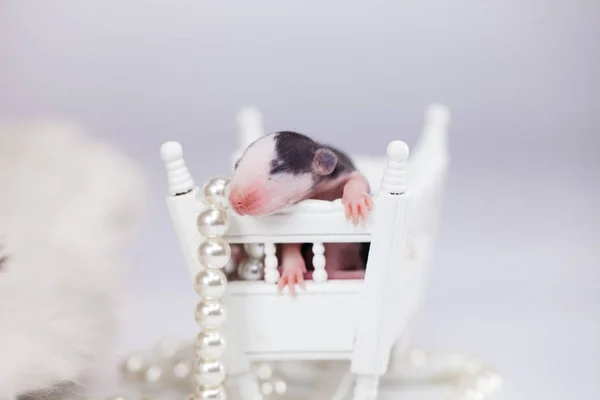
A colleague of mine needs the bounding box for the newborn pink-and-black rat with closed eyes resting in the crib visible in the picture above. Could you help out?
[228,131,373,295]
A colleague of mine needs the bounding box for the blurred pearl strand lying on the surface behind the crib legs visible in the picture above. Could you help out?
[112,341,503,400]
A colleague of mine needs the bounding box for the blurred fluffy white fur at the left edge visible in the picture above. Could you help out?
[0,123,144,400]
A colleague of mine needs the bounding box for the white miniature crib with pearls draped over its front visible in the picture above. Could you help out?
[161,105,449,400]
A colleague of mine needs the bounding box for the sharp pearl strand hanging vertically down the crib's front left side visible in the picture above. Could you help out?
[190,178,231,400]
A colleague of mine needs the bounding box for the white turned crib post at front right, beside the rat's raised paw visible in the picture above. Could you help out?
[351,141,408,400]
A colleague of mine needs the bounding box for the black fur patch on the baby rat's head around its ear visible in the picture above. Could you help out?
[270,131,356,186]
